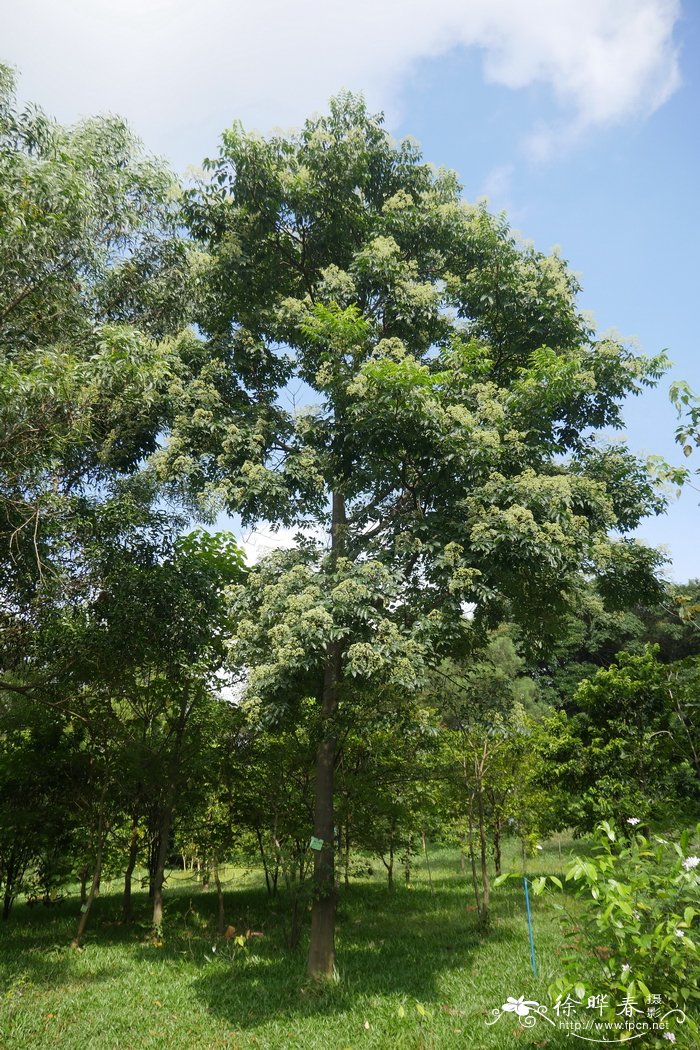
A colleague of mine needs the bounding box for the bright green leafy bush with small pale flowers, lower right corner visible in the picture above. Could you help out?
[533,818,700,1047]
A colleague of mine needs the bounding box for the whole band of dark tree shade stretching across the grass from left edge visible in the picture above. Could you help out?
[0,860,558,1030]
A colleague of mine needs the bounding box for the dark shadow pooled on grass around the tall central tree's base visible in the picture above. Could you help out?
[188,885,518,1030]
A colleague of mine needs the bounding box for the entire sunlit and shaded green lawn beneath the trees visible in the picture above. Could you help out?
[0,843,571,1050]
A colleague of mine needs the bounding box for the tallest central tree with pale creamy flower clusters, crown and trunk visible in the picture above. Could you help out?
[174,96,663,974]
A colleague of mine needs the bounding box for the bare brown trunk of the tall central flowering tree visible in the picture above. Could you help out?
[309,492,345,978]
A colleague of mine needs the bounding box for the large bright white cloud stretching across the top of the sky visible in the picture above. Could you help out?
[0,0,680,165]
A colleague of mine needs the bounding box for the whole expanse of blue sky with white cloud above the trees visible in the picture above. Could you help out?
[5,0,700,581]
